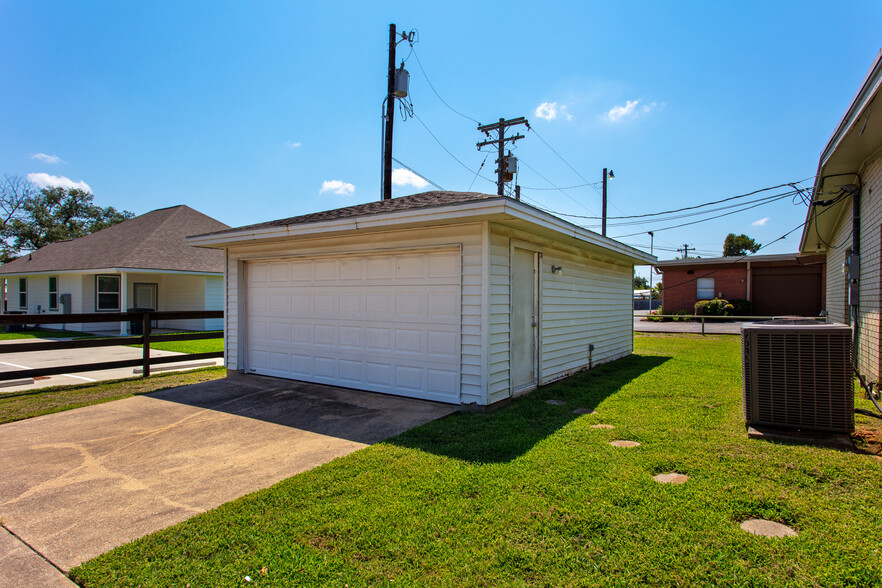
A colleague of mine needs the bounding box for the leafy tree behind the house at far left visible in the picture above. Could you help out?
[0,176,134,263]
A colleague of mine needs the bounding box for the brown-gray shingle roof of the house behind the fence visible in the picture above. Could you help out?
[0,206,229,275]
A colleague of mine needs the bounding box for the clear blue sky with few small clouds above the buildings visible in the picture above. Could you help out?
[0,0,882,275]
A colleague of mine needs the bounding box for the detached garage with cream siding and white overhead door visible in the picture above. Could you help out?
[187,192,655,406]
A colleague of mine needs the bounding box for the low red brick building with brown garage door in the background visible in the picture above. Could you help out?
[656,253,825,316]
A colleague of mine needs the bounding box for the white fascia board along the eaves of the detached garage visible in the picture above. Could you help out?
[187,197,657,264]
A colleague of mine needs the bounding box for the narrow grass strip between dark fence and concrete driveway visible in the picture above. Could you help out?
[0,367,226,424]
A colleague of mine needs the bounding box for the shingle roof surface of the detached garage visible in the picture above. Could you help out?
[194,191,503,234]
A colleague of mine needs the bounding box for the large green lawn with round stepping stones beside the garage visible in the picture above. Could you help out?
[72,335,882,587]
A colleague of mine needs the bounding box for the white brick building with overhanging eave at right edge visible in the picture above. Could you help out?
[800,52,882,381]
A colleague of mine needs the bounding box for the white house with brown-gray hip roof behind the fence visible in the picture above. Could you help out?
[0,206,229,334]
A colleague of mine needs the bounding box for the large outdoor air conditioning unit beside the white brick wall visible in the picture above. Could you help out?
[741,320,854,432]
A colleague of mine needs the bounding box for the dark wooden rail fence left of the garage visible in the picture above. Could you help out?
[0,310,224,381]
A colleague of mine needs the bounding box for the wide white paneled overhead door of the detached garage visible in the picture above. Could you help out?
[245,249,461,403]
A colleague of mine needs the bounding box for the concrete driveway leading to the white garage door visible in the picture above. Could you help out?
[0,376,458,586]
